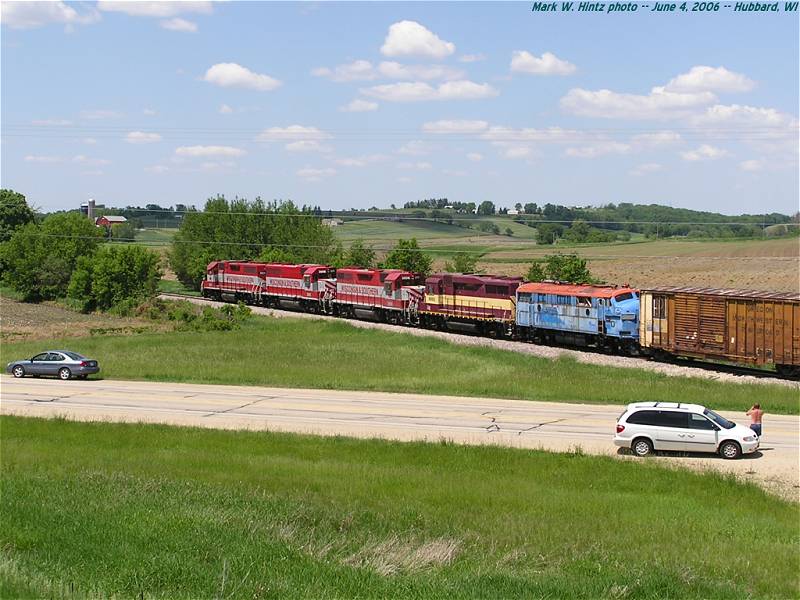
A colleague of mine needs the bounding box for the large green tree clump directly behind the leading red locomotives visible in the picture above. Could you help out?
[169,196,341,287]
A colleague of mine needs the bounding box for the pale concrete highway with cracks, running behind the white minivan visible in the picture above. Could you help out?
[0,375,800,500]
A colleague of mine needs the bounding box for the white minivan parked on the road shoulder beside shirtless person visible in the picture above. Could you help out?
[614,402,759,458]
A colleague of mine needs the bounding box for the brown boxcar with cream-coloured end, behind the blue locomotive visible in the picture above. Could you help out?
[639,287,800,375]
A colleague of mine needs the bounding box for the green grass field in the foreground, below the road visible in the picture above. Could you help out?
[0,417,800,599]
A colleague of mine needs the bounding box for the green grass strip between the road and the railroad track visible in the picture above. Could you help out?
[0,317,800,414]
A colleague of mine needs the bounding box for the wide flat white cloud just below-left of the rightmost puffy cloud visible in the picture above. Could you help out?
[560,87,716,119]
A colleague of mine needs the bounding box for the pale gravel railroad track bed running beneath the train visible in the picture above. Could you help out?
[159,293,797,381]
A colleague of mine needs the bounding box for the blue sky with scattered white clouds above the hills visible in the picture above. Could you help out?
[1,2,800,214]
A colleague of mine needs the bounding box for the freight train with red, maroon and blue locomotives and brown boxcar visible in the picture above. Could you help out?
[201,261,800,377]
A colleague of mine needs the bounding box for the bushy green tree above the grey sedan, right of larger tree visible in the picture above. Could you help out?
[67,244,161,311]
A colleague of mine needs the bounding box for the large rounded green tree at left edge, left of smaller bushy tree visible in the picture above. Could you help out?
[2,212,103,301]
